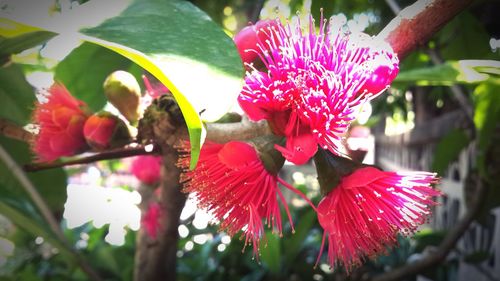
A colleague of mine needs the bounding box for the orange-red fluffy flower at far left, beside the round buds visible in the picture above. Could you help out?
[32,83,87,162]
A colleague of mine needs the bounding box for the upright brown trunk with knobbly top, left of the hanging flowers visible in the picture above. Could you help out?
[134,96,188,281]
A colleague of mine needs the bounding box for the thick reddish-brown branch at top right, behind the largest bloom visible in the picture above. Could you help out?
[378,0,473,59]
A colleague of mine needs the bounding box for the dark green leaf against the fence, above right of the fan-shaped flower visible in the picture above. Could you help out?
[432,129,470,175]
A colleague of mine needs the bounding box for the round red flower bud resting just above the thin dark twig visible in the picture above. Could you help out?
[83,111,130,150]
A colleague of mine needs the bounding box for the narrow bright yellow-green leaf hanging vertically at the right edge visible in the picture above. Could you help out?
[474,83,500,175]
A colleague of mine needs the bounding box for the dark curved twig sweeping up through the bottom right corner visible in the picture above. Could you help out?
[372,179,488,281]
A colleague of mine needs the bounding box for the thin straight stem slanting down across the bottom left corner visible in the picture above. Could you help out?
[0,145,102,281]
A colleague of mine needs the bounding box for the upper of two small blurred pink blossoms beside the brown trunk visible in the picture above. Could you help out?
[130,155,161,185]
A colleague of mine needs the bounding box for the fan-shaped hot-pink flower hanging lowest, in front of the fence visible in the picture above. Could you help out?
[316,167,441,271]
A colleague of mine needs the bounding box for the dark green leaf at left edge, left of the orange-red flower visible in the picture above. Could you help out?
[0,64,35,125]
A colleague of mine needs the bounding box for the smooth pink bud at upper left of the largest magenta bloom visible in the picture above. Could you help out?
[234,20,277,64]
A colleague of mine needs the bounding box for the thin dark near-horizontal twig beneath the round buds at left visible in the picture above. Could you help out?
[24,146,159,172]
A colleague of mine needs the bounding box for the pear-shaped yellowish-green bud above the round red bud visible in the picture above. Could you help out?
[104,70,141,125]
